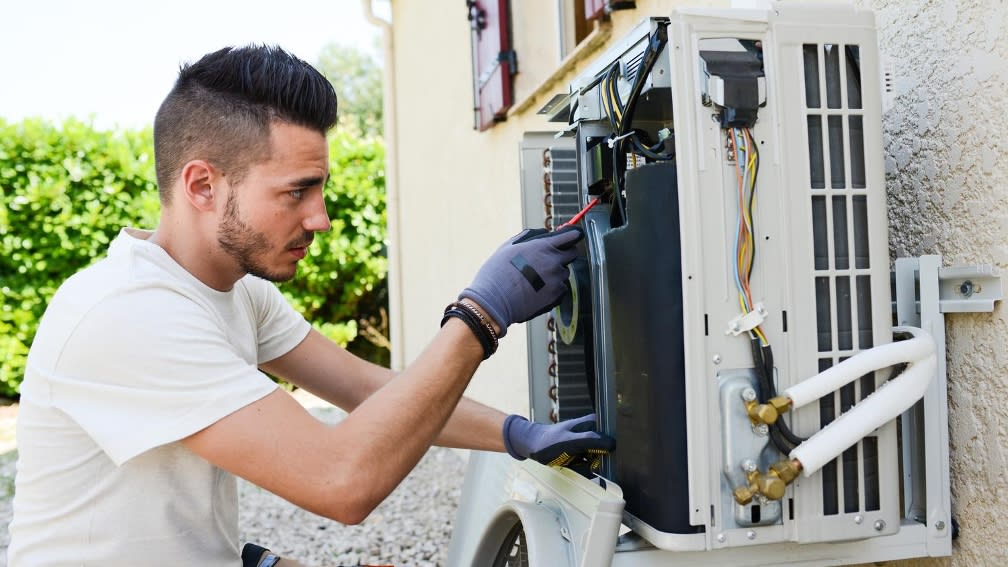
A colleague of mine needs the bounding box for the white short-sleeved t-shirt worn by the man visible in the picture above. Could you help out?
[8,229,309,567]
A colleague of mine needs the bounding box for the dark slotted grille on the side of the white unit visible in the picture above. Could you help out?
[802,43,881,516]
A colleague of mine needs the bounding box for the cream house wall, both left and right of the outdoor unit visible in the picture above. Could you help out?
[390,0,1008,567]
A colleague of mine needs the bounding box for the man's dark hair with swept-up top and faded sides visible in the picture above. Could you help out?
[154,45,337,204]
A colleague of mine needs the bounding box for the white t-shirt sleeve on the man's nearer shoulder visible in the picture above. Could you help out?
[50,289,288,465]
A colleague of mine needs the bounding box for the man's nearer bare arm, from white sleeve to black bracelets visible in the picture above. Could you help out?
[182,320,483,524]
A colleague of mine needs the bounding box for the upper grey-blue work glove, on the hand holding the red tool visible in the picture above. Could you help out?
[459,226,585,337]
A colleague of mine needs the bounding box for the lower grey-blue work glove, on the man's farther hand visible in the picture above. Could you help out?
[504,414,616,470]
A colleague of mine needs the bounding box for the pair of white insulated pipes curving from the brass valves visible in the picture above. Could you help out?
[784,327,937,477]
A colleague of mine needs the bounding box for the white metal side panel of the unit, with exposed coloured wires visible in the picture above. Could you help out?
[669,3,899,549]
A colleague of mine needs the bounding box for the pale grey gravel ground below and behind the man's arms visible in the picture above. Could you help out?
[0,392,465,567]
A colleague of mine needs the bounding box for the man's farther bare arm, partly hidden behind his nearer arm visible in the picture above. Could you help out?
[262,330,506,451]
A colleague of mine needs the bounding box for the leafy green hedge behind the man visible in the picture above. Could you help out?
[0,119,388,398]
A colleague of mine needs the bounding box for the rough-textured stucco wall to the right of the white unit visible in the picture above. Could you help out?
[865,0,1008,567]
